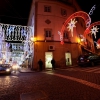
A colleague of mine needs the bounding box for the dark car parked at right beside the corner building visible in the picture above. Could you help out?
[77,54,100,66]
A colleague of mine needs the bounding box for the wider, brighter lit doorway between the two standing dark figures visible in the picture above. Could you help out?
[45,52,53,68]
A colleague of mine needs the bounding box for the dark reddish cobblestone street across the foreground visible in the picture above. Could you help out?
[0,67,100,100]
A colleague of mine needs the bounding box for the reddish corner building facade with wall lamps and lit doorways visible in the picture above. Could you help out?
[28,0,95,69]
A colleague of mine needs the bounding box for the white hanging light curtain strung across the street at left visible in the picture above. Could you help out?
[0,23,33,42]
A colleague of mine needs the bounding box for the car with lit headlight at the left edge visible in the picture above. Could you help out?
[0,64,11,74]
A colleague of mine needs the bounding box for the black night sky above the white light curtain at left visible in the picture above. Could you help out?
[0,0,32,26]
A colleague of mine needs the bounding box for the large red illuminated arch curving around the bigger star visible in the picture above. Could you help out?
[58,11,91,44]
